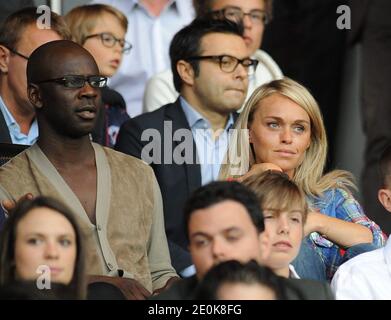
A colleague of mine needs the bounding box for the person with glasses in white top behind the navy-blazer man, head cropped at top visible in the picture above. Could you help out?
[143,0,282,112]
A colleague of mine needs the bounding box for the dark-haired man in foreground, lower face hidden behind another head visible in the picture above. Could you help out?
[156,181,333,300]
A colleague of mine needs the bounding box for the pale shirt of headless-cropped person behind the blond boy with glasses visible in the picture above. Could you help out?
[92,0,194,117]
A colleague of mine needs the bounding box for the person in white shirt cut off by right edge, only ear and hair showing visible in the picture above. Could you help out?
[331,145,391,300]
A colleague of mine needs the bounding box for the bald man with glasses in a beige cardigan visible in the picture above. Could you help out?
[0,40,177,299]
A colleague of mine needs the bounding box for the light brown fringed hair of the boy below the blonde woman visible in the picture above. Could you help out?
[242,170,308,225]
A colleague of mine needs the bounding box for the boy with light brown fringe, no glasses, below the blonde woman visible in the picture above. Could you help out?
[242,171,308,278]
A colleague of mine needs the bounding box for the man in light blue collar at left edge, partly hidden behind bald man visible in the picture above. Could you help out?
[0,7,71,145]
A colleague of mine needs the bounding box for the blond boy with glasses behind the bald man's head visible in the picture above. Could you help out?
[65,4,132,147]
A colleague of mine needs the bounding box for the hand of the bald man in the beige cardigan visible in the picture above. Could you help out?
[88,276,151,300]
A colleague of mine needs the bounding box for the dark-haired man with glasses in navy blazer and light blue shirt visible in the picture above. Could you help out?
[115,19,253,276]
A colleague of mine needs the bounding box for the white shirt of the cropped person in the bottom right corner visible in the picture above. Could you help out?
[331,235,391,300]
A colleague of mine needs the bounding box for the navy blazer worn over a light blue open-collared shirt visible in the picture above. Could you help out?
[115,98,237,272]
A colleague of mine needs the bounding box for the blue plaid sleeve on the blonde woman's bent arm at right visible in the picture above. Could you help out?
[335,189,387,247]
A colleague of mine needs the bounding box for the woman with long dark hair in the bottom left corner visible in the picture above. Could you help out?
[0,197,86,299]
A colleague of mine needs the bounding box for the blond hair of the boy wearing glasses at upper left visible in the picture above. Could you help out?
[64,4,128,45]
